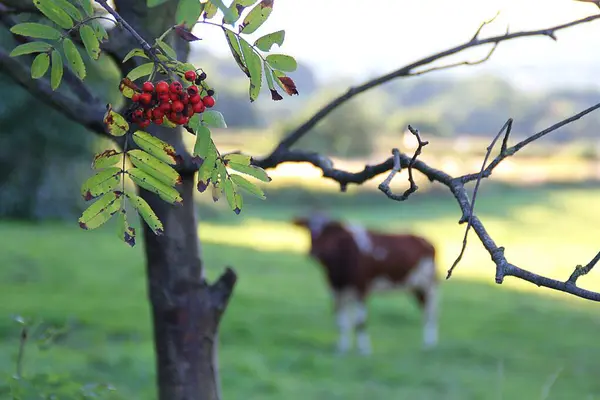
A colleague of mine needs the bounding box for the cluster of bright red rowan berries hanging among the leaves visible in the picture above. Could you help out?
[130,70,215,129]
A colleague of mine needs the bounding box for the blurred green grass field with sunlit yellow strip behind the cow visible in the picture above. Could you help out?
[0,188,600,400]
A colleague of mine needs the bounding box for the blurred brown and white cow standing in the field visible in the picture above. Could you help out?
[293,213,438,354]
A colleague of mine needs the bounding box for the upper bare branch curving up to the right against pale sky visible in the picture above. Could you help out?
[258,14,600,159]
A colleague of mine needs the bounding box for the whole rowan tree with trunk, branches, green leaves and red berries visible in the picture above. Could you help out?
[0,0,600,400]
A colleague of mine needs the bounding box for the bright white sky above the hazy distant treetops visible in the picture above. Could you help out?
[195,0,600,87]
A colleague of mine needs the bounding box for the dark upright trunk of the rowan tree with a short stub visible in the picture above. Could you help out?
[112,0,236,400]
